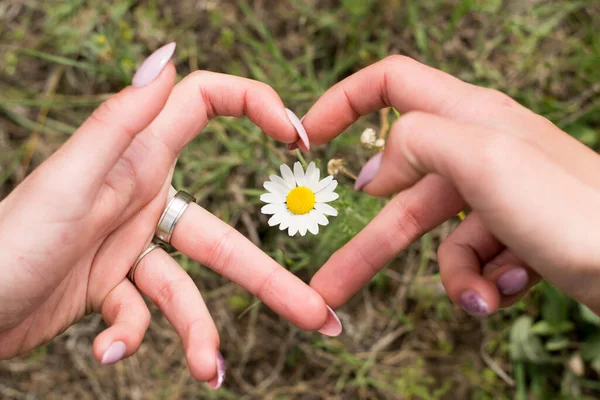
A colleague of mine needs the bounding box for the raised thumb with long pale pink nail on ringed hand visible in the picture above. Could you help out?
[47,43,175,195]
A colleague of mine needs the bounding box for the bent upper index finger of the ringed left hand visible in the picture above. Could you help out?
[101,71,308,215]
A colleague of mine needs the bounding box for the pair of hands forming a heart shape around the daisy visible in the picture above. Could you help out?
[0,43,600,387]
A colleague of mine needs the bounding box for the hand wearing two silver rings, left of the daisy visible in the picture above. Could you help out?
[0,44,341,387]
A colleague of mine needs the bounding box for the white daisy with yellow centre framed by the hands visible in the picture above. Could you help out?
[260,162,339,236]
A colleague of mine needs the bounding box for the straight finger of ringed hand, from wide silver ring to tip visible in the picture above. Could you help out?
[172,203,338,334]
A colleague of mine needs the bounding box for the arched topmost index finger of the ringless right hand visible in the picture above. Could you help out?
[302,55,518,145]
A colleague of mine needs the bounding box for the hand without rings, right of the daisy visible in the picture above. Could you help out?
[303,56,600,316]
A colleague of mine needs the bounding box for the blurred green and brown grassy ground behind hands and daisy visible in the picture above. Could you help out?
[0,0,600,399]
